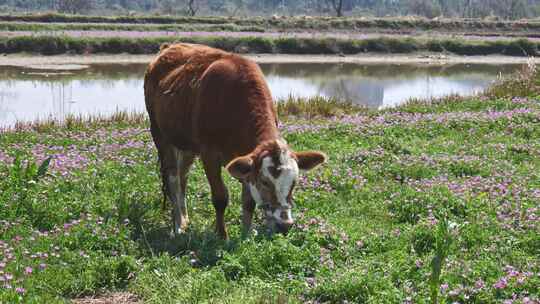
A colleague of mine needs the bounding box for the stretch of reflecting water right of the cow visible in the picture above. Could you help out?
[262,64,520,108]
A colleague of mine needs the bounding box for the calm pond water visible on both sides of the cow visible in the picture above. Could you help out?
[0,63,520,127]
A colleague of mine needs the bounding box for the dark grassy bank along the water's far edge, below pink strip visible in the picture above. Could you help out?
[0,35,538,56]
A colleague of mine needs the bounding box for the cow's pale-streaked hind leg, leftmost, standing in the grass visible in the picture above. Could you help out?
[162,146,195,234]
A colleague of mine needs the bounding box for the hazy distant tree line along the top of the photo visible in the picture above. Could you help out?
[0,0,540,20]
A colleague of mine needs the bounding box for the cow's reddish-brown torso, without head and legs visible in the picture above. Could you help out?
[145,44,277,160]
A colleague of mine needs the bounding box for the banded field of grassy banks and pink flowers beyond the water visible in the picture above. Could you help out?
[0,14,540,56]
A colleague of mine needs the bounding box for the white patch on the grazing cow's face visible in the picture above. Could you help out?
[261,150,299,208]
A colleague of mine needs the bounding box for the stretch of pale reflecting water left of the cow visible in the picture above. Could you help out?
[0,65,145,127]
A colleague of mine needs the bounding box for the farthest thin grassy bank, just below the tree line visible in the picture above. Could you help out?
[5,14,540,32]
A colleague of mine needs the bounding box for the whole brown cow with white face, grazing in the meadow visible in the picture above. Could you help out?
[144,44,326,238]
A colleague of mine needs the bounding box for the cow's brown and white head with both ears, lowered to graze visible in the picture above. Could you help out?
[227,139,326,232]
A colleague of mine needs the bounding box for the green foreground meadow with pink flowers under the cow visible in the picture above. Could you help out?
[0,65,540,303]
